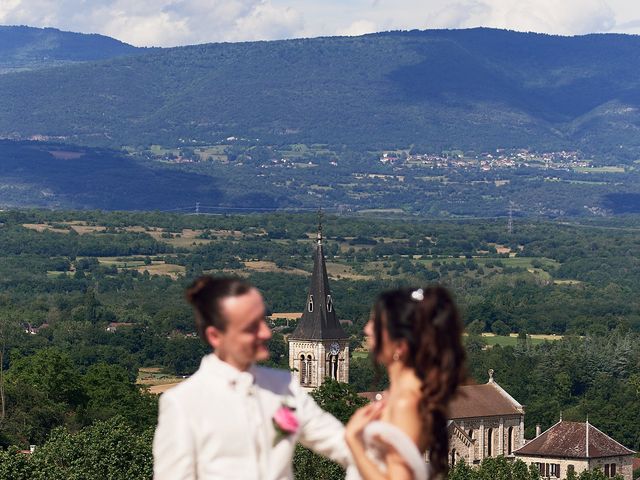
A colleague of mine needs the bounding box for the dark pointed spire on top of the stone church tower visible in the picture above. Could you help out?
[289,213,349,340]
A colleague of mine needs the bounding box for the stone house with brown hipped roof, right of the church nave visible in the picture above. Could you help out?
[514,420,635,480]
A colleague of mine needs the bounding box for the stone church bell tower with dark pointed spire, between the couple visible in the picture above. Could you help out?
[289,224,349,390]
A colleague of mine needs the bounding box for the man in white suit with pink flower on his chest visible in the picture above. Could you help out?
[153,277,349,480]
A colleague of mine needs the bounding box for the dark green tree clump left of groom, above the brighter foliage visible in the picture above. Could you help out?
[0,347,157,447]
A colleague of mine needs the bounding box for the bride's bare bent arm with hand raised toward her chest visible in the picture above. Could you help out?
[345,402,413,480]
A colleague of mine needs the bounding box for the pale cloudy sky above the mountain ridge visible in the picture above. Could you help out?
[0,0,640,47]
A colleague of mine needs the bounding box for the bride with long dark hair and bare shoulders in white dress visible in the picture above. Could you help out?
[346,286,465,480]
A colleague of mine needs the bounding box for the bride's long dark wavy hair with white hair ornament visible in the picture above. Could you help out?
[373,286,466,477]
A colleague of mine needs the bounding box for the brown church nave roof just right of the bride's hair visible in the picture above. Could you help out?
[449,381,524,419]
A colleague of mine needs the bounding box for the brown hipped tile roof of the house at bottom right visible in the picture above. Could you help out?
[514,420,634,459]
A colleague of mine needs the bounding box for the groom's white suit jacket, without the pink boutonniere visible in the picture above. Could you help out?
[153,354,350,480]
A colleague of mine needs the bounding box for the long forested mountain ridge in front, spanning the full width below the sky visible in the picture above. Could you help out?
[0,29,640,159]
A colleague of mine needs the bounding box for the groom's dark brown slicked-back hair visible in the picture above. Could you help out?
[185,275,253,342]
